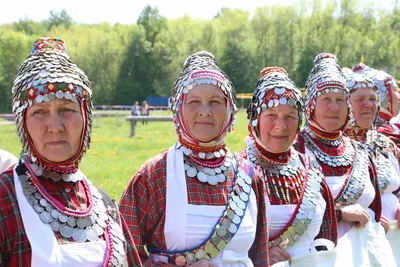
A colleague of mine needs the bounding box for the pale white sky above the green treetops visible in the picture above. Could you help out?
[0,0,299,24]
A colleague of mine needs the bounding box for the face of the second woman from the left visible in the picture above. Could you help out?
[182,84,228,143]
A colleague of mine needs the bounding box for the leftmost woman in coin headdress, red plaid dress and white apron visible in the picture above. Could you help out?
[0,38,141,267]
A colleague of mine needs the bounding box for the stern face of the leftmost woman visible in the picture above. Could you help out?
[25,99,83,162]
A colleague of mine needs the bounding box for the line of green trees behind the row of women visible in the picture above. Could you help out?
[0,0,400,113]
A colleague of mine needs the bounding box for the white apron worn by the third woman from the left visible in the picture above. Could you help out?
[267,181,336,267]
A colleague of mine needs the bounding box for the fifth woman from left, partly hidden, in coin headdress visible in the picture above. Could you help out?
[343,68,400,264]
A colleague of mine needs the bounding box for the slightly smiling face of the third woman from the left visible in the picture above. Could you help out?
[258,105,299,153]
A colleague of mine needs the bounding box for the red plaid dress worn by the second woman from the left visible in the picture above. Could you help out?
[120,151,268,267]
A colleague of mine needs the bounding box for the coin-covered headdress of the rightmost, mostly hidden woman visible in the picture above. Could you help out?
[353,63,398,118]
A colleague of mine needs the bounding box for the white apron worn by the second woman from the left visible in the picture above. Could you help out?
[150,148,257,267]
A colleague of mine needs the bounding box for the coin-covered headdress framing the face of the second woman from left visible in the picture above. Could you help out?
[170,51,237,147]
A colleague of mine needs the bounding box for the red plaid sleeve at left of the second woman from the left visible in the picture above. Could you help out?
[119,152,172,266]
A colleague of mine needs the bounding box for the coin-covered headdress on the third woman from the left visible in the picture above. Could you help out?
[247,67,304,140]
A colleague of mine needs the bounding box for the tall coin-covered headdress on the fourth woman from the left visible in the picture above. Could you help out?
[305,53,355,130]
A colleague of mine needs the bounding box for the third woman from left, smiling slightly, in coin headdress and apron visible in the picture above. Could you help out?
[242,67,337,266]
